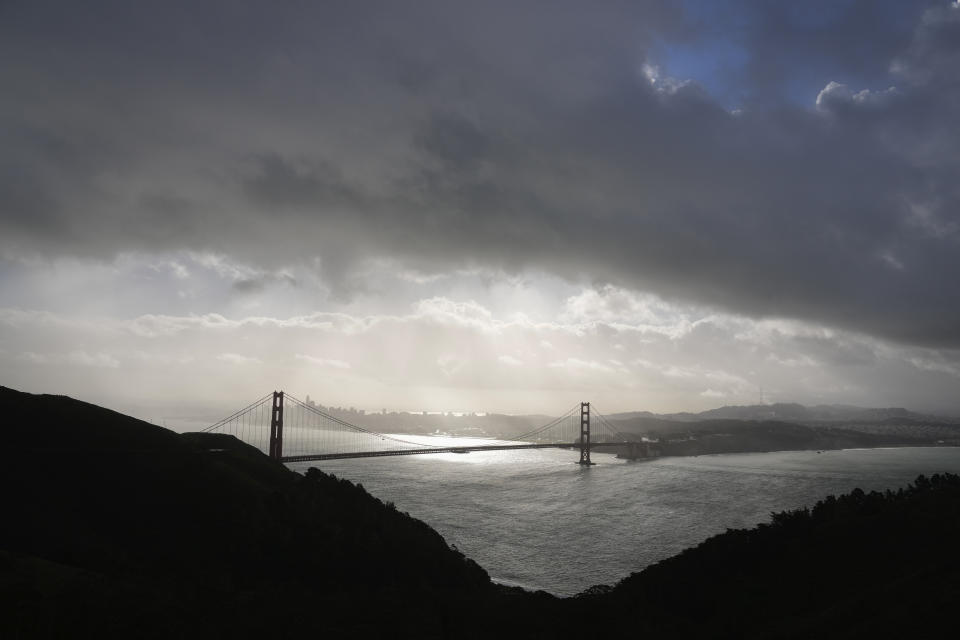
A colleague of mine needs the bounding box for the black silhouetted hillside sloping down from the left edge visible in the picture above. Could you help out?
[0,388,510,637]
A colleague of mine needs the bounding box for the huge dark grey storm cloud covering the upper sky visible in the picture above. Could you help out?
[0,2,960,346]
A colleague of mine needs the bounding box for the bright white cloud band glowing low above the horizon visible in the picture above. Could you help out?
[0,288,960,413]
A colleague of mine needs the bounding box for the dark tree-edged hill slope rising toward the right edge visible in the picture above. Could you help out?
[571,474,960,638]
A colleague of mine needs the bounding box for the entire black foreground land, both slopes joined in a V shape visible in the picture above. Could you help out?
[0,388,960,639]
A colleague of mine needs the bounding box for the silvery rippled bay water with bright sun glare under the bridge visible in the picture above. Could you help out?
[290,444,960,596]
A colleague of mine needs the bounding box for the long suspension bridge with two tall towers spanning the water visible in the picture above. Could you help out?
[204,391,650,465]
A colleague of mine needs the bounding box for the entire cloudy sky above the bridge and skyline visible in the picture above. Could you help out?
[0,0,960,421]
